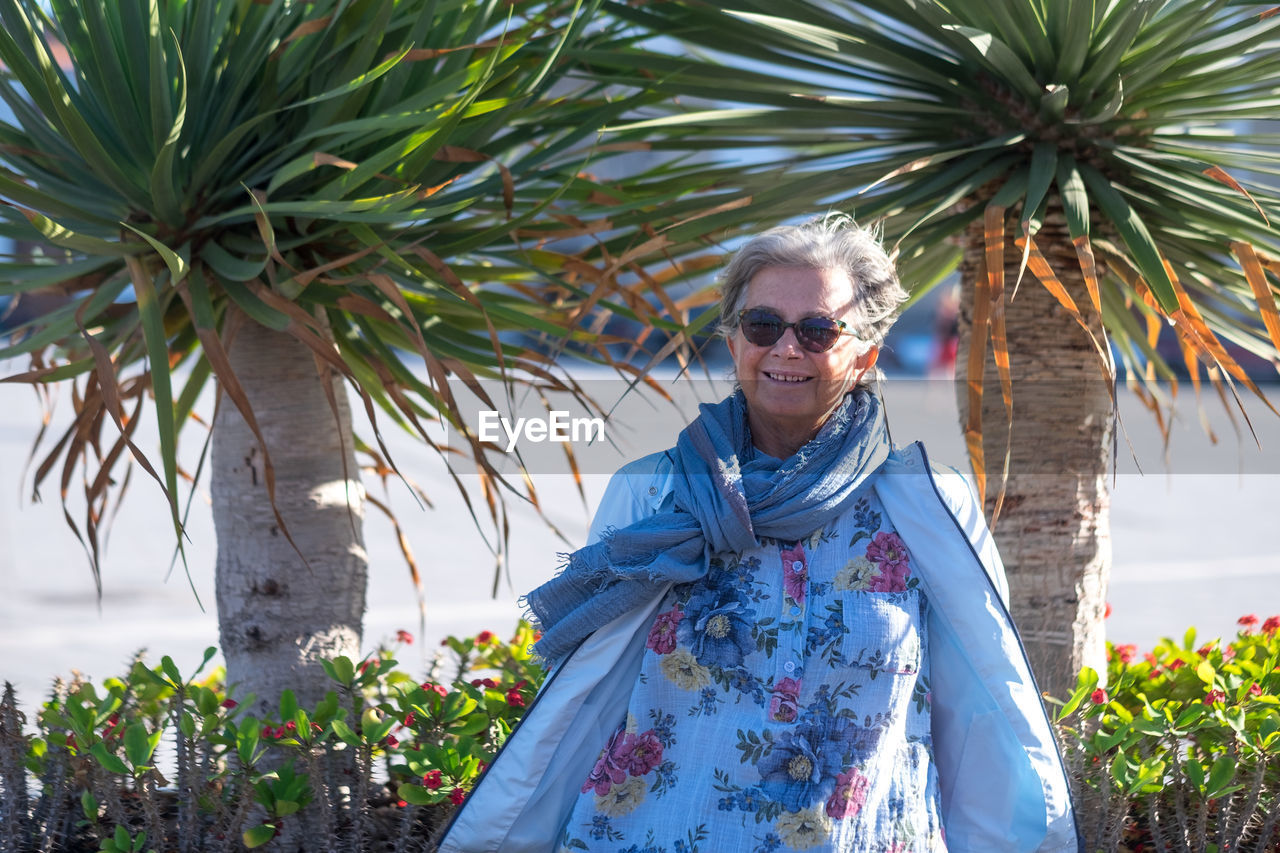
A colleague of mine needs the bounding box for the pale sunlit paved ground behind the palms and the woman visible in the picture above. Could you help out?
[0,382,1280,707]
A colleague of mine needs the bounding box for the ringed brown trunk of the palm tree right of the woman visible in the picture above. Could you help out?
[956,206,1112,698]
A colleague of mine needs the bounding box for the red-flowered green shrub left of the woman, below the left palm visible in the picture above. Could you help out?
[0,622,543,853]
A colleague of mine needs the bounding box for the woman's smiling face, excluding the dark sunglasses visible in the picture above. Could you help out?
[728,266,878,459]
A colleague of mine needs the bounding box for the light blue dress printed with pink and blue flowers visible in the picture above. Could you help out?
[559,488,946,853]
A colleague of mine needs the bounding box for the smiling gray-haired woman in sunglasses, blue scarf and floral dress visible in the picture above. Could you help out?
[440,216,1078,853]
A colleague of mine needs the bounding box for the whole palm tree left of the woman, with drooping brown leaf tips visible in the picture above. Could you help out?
[0,0,727,711]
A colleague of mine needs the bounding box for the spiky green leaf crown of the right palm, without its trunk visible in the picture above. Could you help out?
[598,0,1280,466]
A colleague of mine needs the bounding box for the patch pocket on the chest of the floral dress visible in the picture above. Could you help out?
[840,589,920,678]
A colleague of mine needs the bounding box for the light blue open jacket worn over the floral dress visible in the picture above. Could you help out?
[440,444,1080,853]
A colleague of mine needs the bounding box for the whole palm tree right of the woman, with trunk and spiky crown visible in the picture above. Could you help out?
[598,0,1280,695]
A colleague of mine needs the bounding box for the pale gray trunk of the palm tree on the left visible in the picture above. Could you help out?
[211,313,369,713]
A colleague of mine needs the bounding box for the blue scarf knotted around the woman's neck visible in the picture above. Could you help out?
[525,389,888,663]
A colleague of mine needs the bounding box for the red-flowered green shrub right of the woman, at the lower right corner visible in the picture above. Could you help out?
[1057,615,1280,853]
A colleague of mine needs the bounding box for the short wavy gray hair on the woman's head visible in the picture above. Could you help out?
[719,213,908,353]
